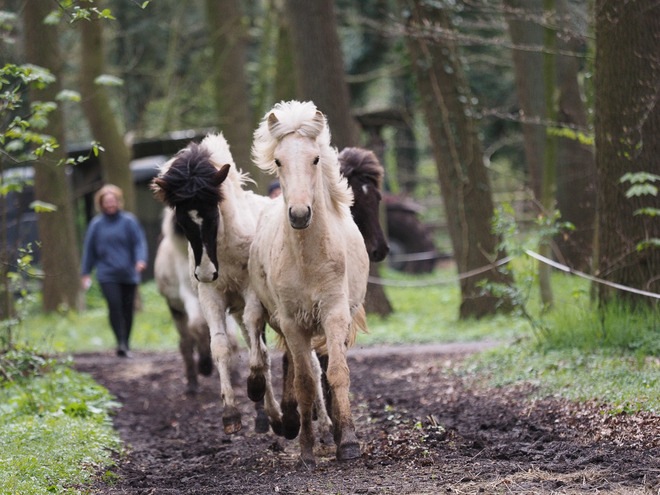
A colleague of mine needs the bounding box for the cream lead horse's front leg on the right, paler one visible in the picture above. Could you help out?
[323,305,360,461]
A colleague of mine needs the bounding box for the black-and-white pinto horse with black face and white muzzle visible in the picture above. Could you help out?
[152,134,282,434]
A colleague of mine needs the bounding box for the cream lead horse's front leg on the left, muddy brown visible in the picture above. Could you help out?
[282,321,316,470]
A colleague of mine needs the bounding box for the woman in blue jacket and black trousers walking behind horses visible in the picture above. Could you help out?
[81,184,147,357]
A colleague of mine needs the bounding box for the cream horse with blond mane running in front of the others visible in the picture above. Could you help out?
[246,101,369,468]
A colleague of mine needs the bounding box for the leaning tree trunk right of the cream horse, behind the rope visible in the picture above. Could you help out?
[399,0,511,318]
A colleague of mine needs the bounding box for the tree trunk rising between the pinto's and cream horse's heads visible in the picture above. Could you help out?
[206,0,268,194]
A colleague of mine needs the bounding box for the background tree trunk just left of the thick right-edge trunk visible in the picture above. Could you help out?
[555,0,596,271]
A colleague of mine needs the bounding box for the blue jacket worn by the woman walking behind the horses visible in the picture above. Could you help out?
[81,210,147,284]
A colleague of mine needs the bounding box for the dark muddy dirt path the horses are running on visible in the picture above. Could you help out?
[76,345,660,495]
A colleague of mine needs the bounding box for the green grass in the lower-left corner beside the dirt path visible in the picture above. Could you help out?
[0,348,120,494]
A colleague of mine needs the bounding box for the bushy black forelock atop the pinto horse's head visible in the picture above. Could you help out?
[152,143,222,208]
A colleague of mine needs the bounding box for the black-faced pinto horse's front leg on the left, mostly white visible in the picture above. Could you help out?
[198,284,241,435]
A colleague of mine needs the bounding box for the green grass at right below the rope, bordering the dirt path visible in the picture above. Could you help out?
[465,262,660,413]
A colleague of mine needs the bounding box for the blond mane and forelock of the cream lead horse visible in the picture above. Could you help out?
[252,101,353,215]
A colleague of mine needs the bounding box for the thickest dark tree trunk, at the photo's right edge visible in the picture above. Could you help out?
[595,0,660,302]
